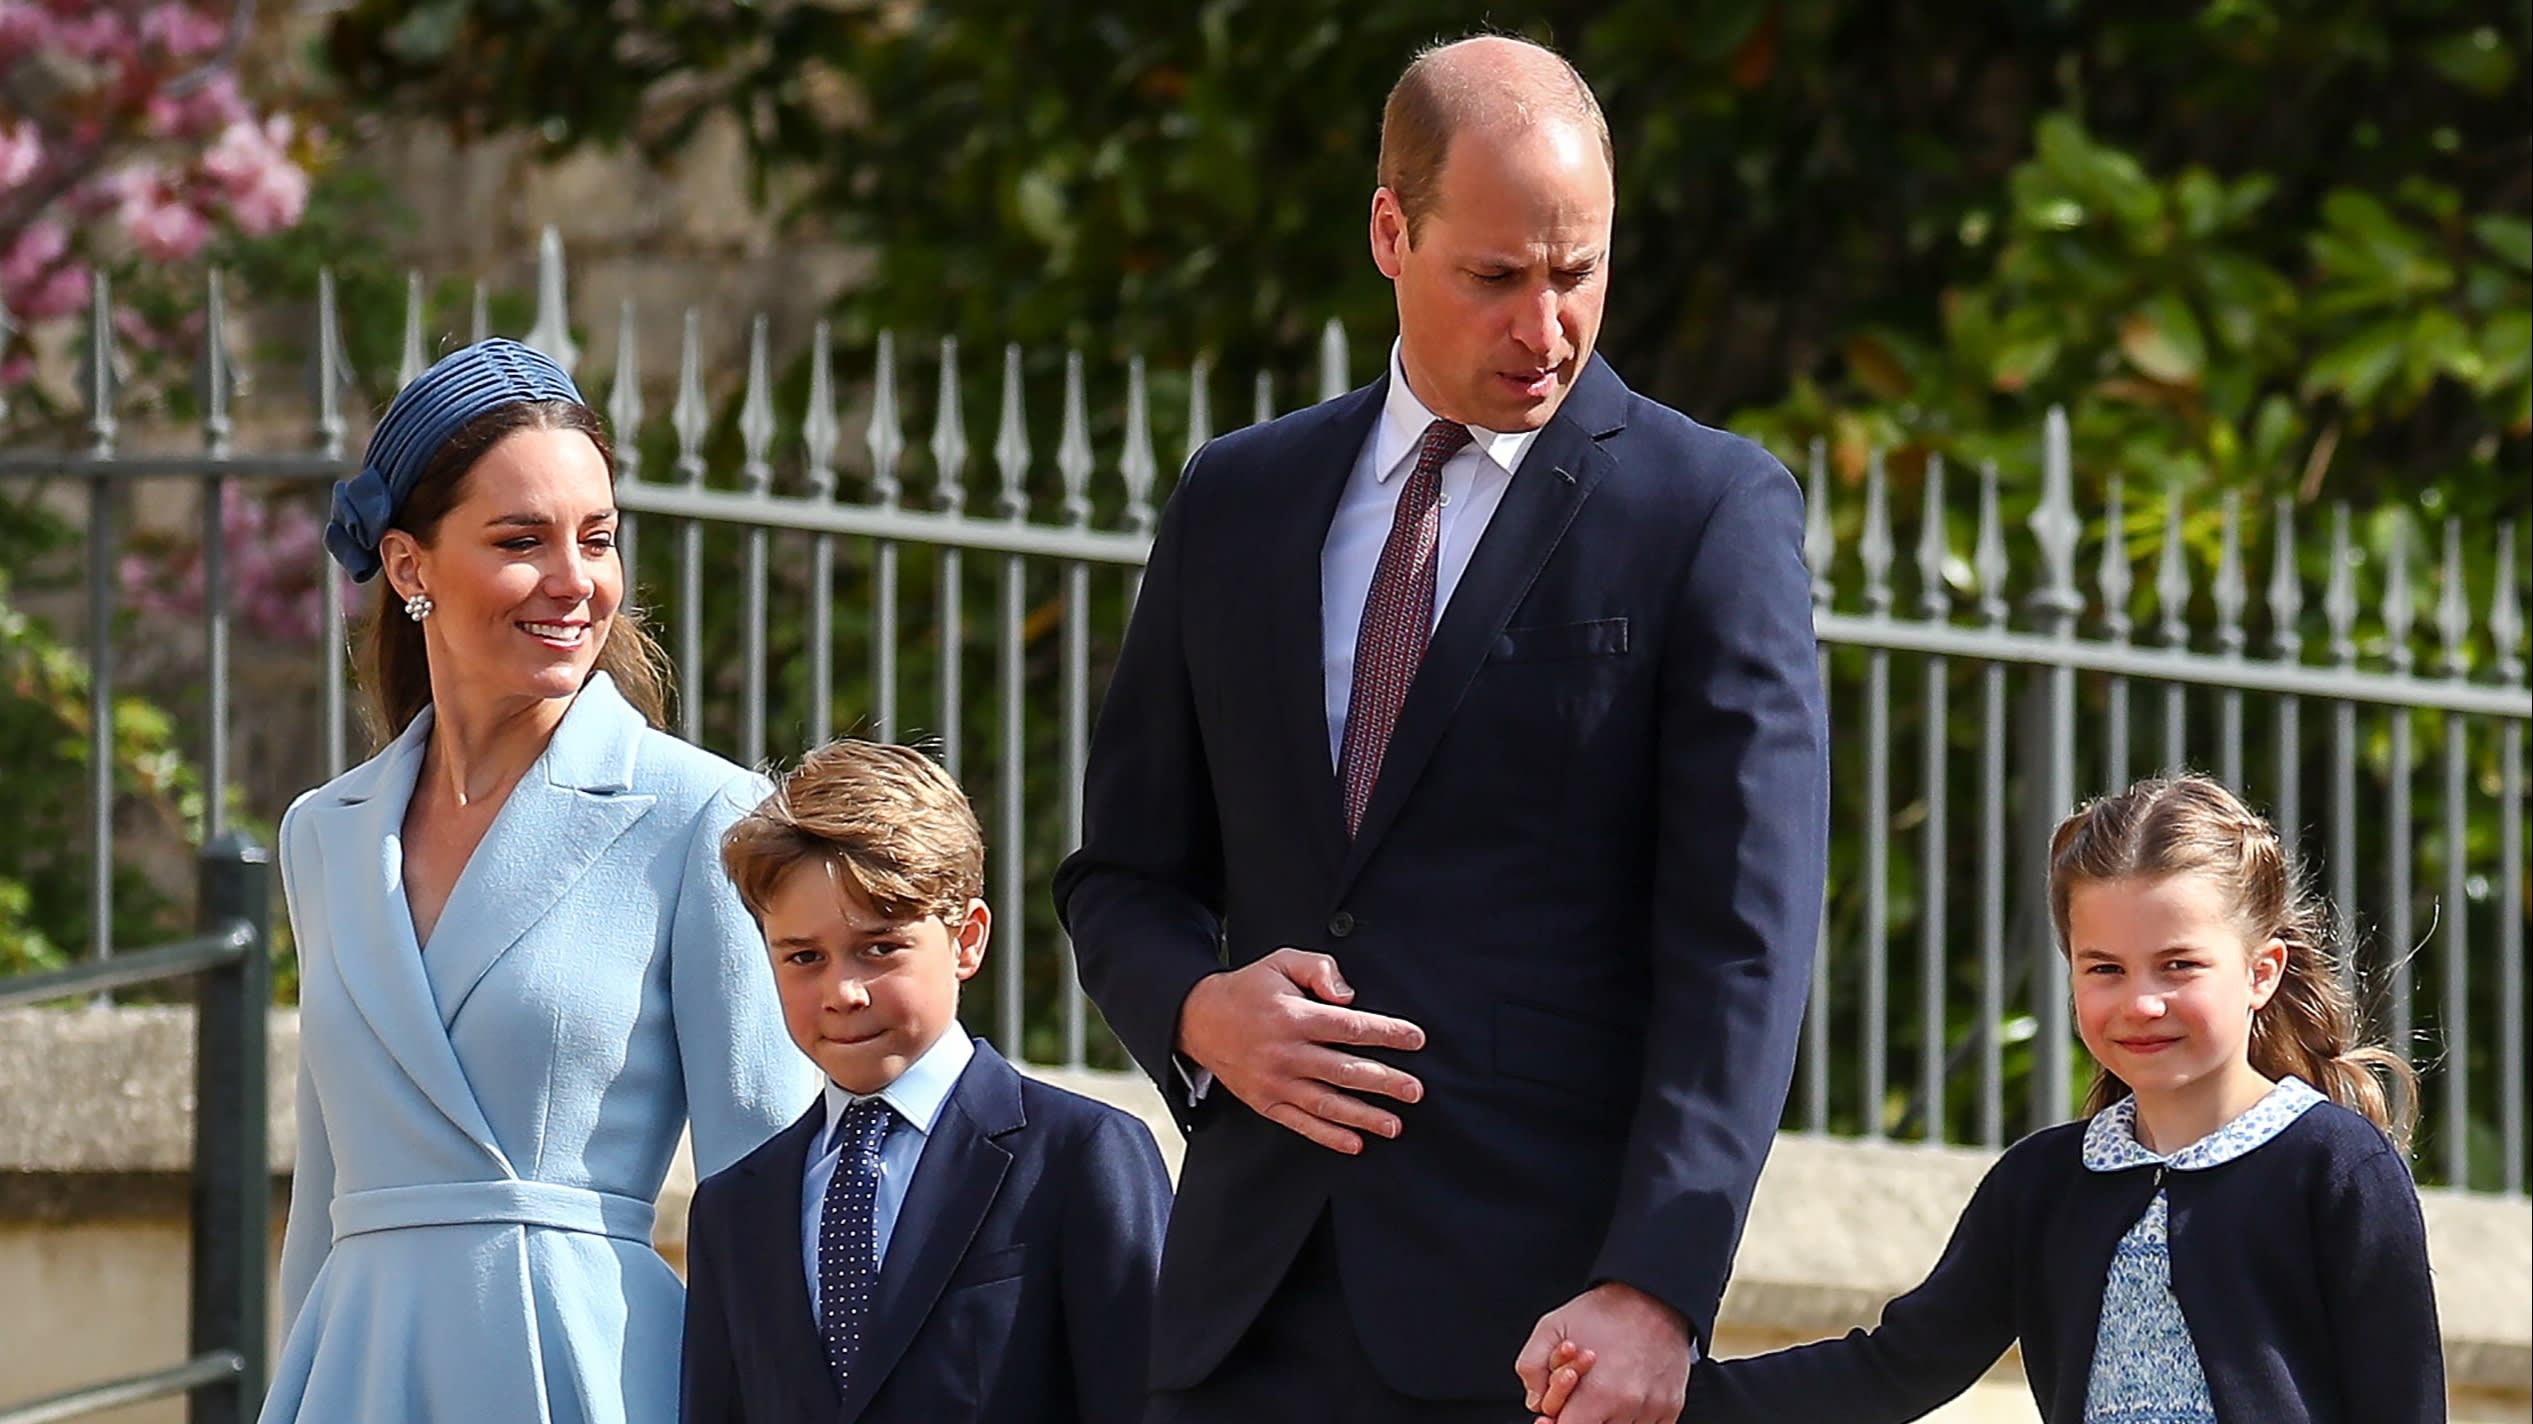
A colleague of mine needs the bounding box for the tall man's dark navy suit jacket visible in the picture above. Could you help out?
[1056,357,1829,1399]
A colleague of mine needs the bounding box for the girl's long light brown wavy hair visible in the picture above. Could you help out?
[2049,773,2419,1148]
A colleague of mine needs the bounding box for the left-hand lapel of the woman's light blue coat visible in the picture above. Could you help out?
[309,709,509,1155]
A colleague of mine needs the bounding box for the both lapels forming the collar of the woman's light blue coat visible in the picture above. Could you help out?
[312,674,654,1155]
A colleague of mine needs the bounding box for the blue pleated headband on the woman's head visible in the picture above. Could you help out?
[324,337,588,583]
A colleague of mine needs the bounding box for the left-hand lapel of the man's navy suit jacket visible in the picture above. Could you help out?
[1264,375,1391,846]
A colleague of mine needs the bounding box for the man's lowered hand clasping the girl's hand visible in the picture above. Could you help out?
[1512,1280,1697,1424]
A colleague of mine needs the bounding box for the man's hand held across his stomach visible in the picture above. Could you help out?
[1178,950,1418,1145]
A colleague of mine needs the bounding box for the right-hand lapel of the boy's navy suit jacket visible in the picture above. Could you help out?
[840,1041,1028,1424]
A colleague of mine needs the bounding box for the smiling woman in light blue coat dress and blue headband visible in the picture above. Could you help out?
[263,340,816,1424]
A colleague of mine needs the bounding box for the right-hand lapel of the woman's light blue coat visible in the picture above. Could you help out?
[423,674,656,1026]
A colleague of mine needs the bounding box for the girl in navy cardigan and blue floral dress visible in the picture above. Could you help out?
[1550,775,2444,1424]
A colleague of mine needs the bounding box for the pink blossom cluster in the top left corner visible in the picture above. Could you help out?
[0,0,312,390]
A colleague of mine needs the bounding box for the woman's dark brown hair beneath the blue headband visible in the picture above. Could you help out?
[360,400,669,745]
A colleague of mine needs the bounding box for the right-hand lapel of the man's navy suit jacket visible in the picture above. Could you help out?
[1322,357,1629,894]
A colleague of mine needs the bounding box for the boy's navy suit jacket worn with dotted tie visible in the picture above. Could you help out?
[681,1041,1170,1424]
